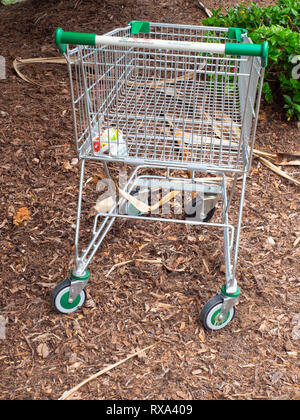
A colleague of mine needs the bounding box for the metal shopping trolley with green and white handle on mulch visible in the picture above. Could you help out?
[52,21,268,330]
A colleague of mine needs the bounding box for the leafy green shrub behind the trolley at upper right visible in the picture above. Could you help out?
[202,0,300,121]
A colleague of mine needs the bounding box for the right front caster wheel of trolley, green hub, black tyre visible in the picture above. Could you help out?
[200,294,235,331]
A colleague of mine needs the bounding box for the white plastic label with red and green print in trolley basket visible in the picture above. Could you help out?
[93,128,127,157]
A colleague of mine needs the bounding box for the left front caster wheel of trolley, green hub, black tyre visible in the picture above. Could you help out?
[51,279,86,314]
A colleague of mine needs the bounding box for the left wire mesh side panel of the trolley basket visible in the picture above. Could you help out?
[67,28,132,157]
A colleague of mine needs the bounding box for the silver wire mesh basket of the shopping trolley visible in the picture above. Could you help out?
[70,24,257,170]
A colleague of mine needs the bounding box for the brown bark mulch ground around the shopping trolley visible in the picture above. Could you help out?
[0,0,300,400]
